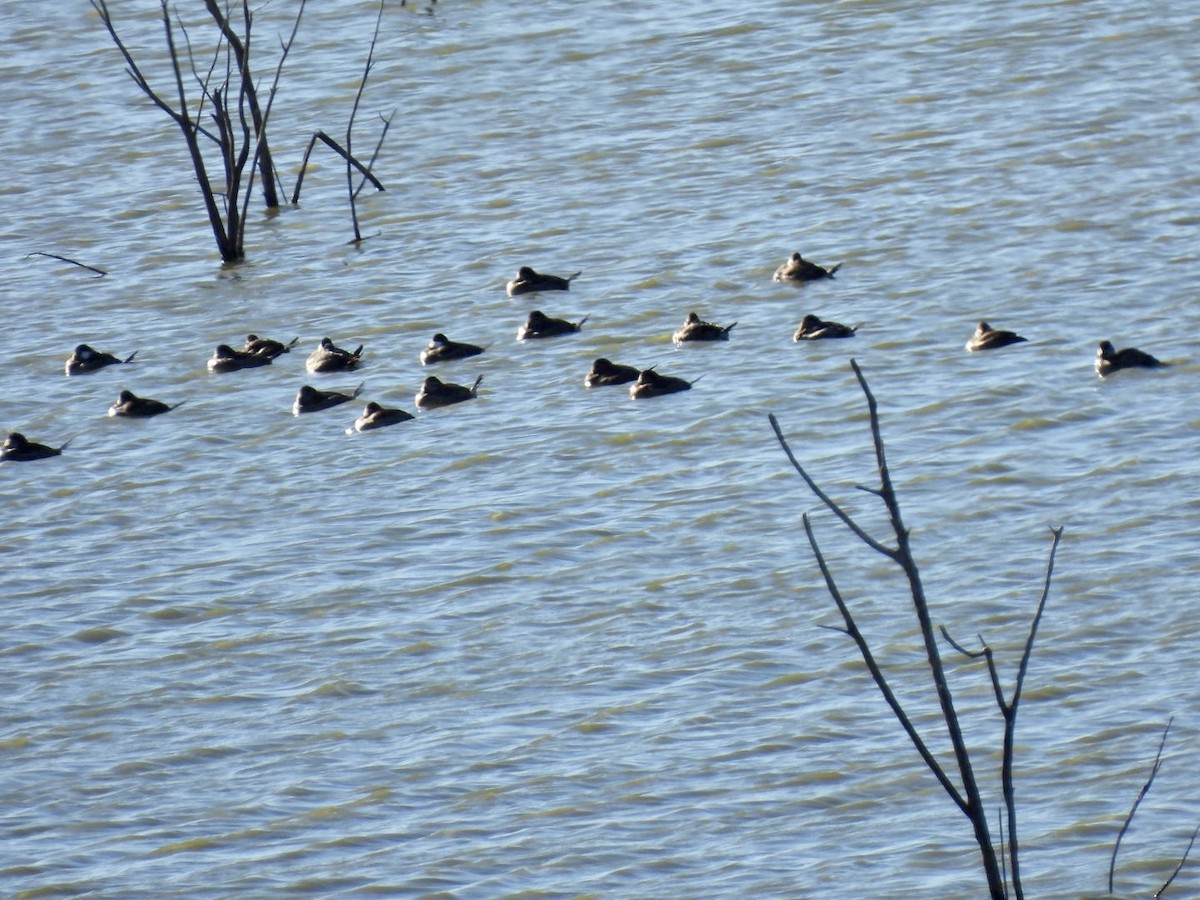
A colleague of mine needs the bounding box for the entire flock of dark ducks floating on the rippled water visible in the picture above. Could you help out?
[0,252,1168,462]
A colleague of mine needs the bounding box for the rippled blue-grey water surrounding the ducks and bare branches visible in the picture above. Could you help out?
[0,0,1200,898]
